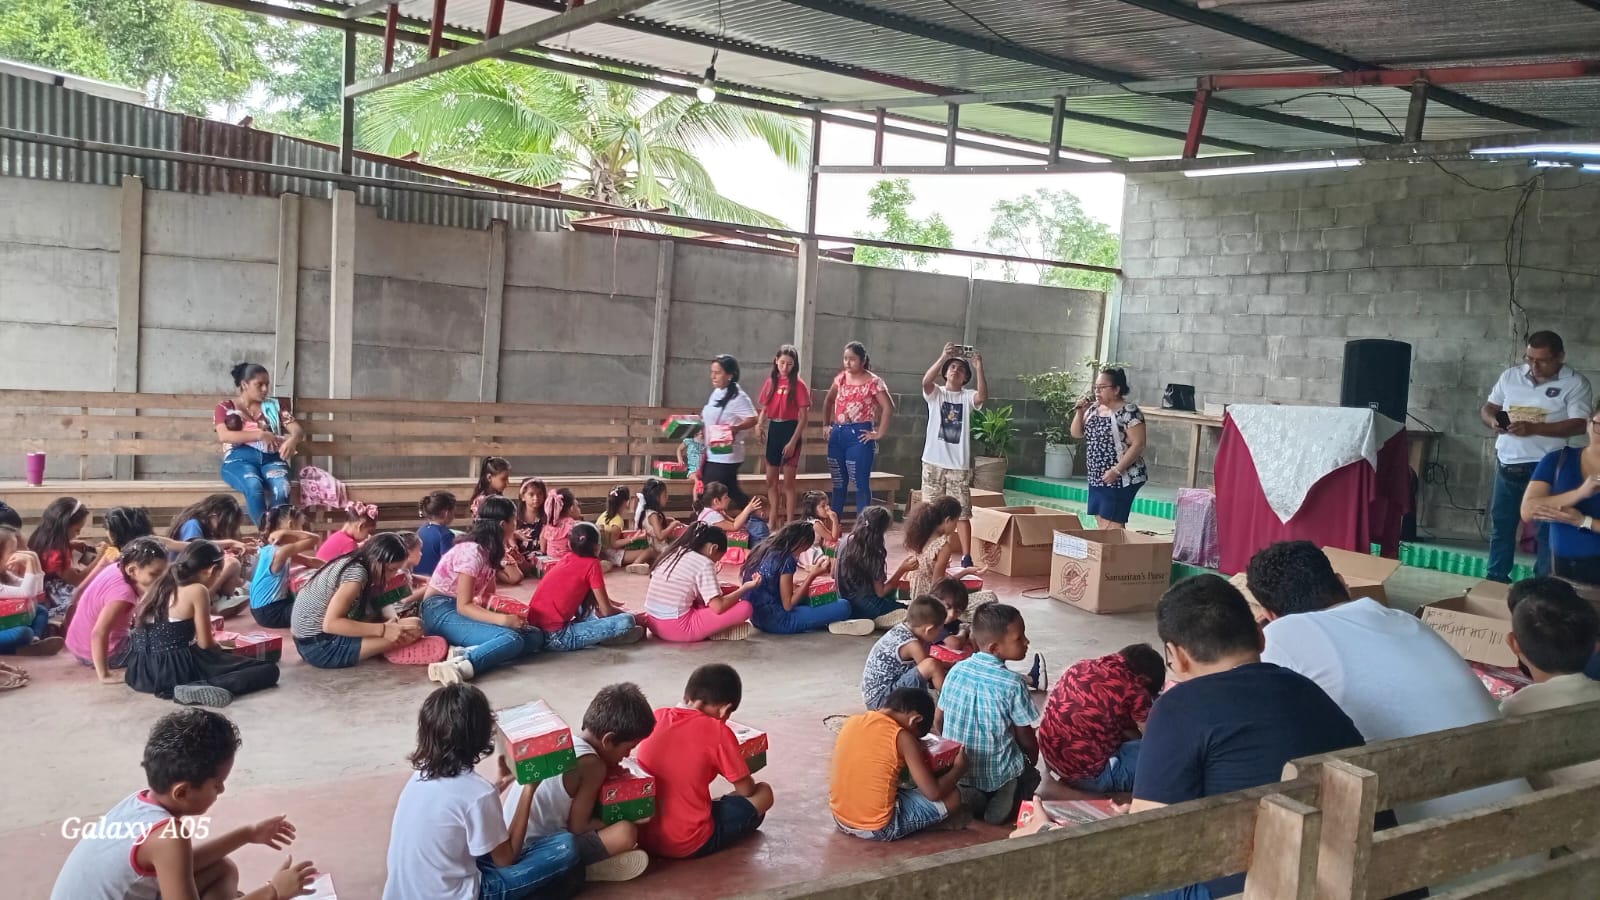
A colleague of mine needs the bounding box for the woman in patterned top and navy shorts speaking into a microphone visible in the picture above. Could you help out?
[1072,368,1150,528]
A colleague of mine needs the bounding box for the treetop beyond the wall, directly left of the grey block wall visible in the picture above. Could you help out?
[984,189,1122,290]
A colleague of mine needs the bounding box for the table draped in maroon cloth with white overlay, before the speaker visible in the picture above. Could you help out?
[1216,407,1411,575]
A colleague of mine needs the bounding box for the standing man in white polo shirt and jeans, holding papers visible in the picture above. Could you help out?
[1478,331,1594,583]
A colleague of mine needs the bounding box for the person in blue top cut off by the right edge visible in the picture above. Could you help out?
[1522,412,1600,601]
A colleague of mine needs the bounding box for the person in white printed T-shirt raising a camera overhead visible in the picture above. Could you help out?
[922,344,989,567]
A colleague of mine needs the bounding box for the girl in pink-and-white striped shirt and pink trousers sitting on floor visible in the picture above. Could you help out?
[642,522,762,642]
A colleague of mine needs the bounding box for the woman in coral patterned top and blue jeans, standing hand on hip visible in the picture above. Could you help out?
[822,341,893,516]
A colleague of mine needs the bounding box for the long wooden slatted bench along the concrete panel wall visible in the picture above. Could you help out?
[0,391,901,525]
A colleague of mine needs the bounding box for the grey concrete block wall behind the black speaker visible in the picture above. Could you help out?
[1117,162,1600,536]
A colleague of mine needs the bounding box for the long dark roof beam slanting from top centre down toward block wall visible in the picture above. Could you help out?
[786,0,1400,149]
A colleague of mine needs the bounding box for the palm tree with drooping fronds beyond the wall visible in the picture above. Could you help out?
[357,61,808,226]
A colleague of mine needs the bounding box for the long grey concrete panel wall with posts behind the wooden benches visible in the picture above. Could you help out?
[0,178,1104,479]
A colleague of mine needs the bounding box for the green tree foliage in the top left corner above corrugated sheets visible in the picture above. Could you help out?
[0,0,283,115]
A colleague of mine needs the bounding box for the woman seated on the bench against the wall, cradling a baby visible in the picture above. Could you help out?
[211,362,306,528]
